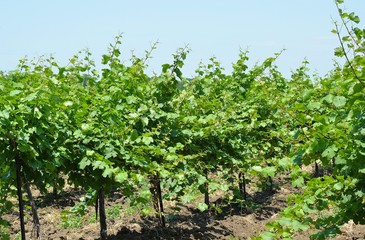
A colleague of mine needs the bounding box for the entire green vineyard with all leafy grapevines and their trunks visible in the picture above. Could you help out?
[0,0,365,239]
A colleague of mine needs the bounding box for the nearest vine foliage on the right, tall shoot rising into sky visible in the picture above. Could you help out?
[261,1,365,239]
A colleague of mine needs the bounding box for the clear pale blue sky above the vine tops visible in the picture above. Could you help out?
[0,0,365,77]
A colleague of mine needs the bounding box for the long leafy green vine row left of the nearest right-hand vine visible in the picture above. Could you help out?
[0,36,306,237]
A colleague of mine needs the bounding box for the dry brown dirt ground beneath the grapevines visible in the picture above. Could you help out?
[4,174,365,240]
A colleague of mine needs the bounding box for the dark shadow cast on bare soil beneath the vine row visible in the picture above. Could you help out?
[108,188,281,240]
